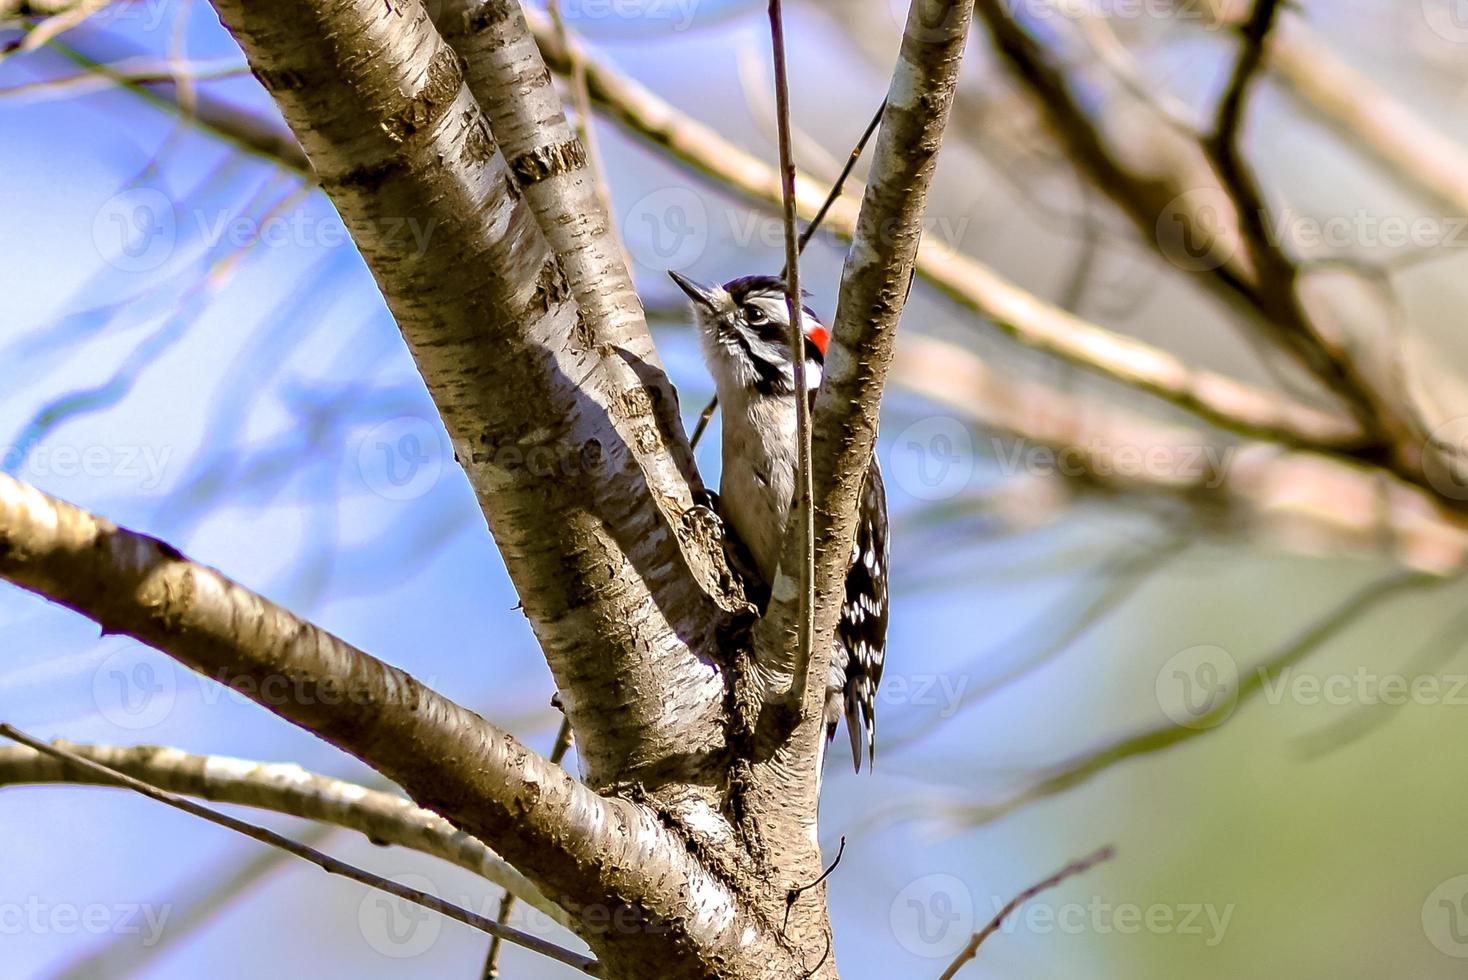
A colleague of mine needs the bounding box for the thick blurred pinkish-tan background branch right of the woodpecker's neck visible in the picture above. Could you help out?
[891,333,1468,575]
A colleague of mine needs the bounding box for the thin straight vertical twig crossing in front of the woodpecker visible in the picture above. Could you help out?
[769,0,816,706]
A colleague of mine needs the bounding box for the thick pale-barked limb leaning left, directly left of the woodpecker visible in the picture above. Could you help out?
[205,0,738,788]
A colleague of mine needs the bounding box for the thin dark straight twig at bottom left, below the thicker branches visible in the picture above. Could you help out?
[0,723,597,976]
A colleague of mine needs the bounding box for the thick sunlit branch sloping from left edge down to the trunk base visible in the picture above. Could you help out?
[0,474,788,976]
